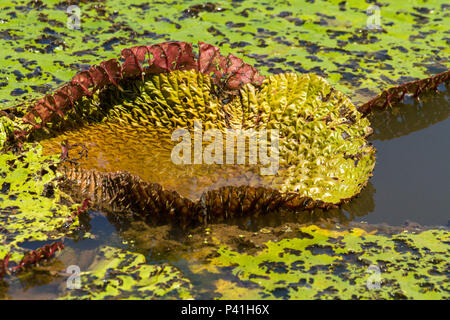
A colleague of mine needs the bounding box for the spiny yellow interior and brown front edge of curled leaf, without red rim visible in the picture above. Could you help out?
[41,70,375,218]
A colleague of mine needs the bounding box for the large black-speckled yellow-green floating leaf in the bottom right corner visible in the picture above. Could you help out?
[211,226,449,299]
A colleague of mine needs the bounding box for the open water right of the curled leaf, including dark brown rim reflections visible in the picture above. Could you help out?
[342,87,450,226]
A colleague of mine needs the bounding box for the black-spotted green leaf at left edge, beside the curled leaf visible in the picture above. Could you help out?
[0,144,78,262]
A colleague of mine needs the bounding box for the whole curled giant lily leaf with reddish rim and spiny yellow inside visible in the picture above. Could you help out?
[16,55,375,222]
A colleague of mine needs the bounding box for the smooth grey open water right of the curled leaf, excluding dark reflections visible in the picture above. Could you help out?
[358,119,450,225]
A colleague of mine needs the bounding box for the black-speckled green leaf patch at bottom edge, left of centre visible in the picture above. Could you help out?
[62,247,192,300]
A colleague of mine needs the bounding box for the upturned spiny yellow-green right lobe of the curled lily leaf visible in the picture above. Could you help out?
[241,73,375,203]
